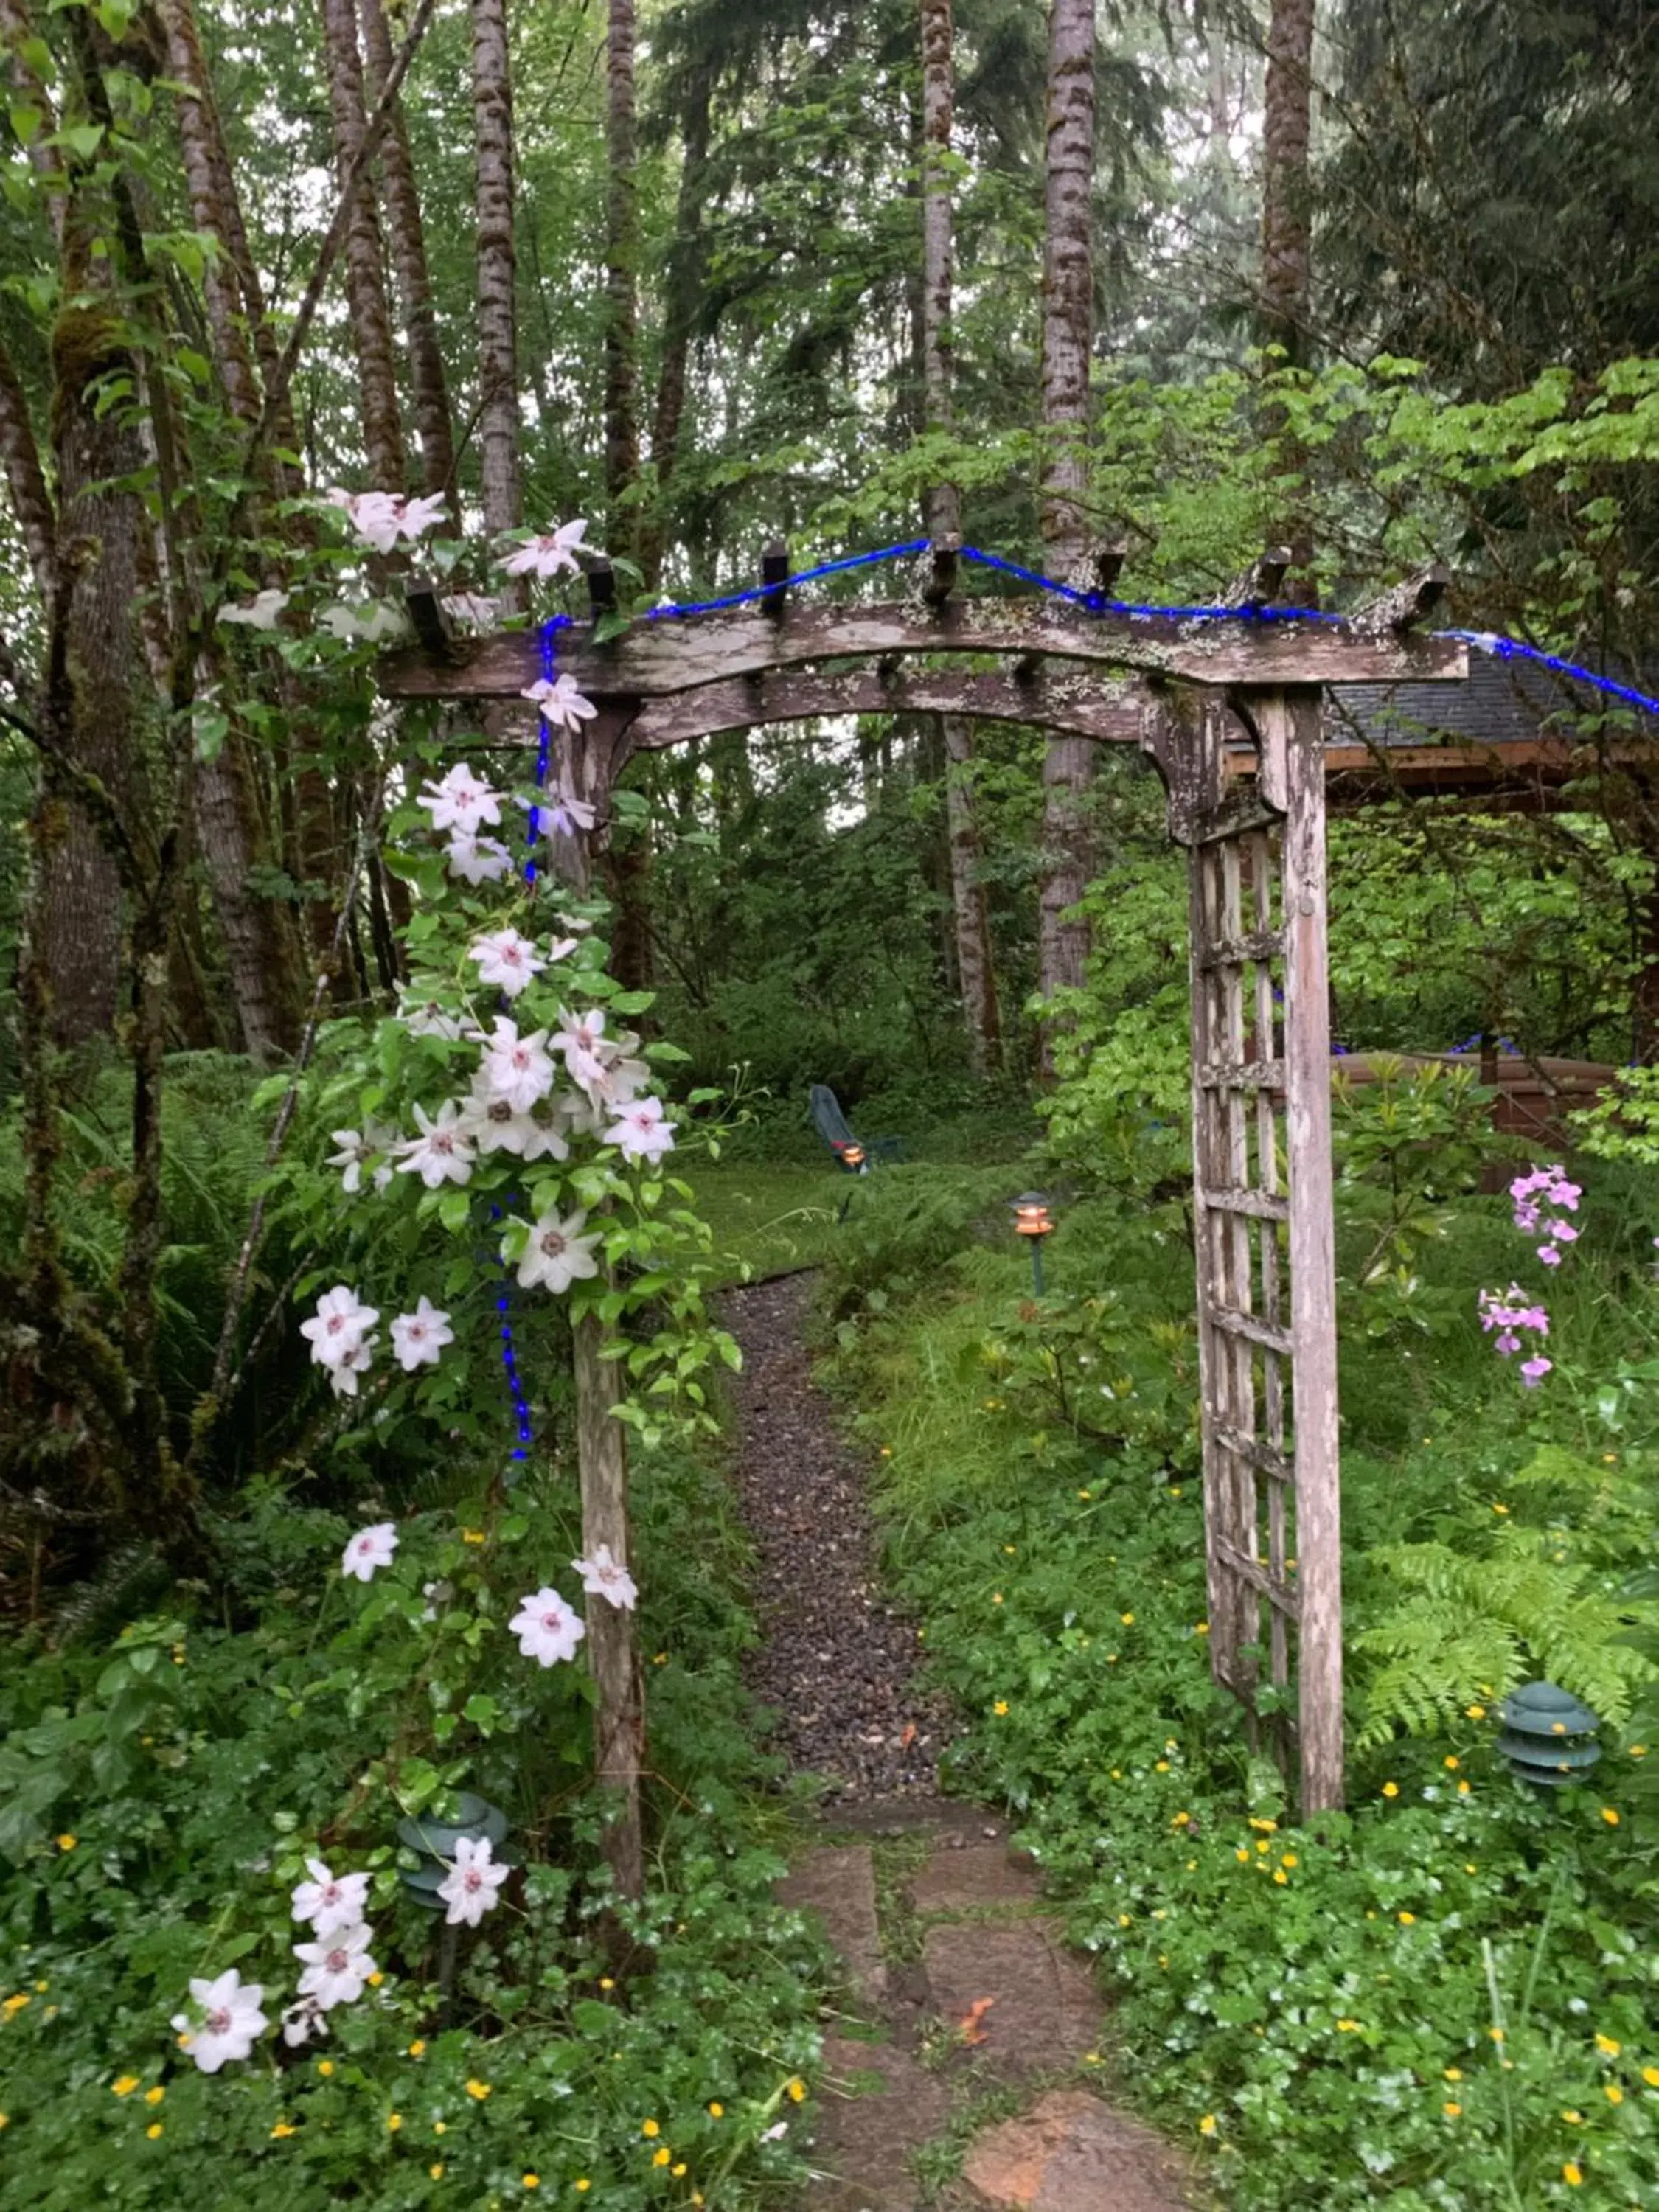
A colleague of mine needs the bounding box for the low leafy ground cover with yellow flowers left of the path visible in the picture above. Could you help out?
[0,1449,821,2212]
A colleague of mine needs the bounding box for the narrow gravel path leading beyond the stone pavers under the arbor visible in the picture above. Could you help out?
[721,1274,949,1803]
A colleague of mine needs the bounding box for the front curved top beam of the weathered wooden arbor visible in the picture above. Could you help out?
[378,599,1469,699]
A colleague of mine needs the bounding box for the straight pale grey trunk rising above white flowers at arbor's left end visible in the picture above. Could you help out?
[473,0,524,571]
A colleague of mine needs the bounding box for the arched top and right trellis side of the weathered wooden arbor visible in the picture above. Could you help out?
[380,540,1467,1814]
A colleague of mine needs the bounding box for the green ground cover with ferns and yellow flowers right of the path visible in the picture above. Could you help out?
[825,1168,1659,2212]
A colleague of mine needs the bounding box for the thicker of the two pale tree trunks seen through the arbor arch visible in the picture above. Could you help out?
[1037,0,1095,1035]
